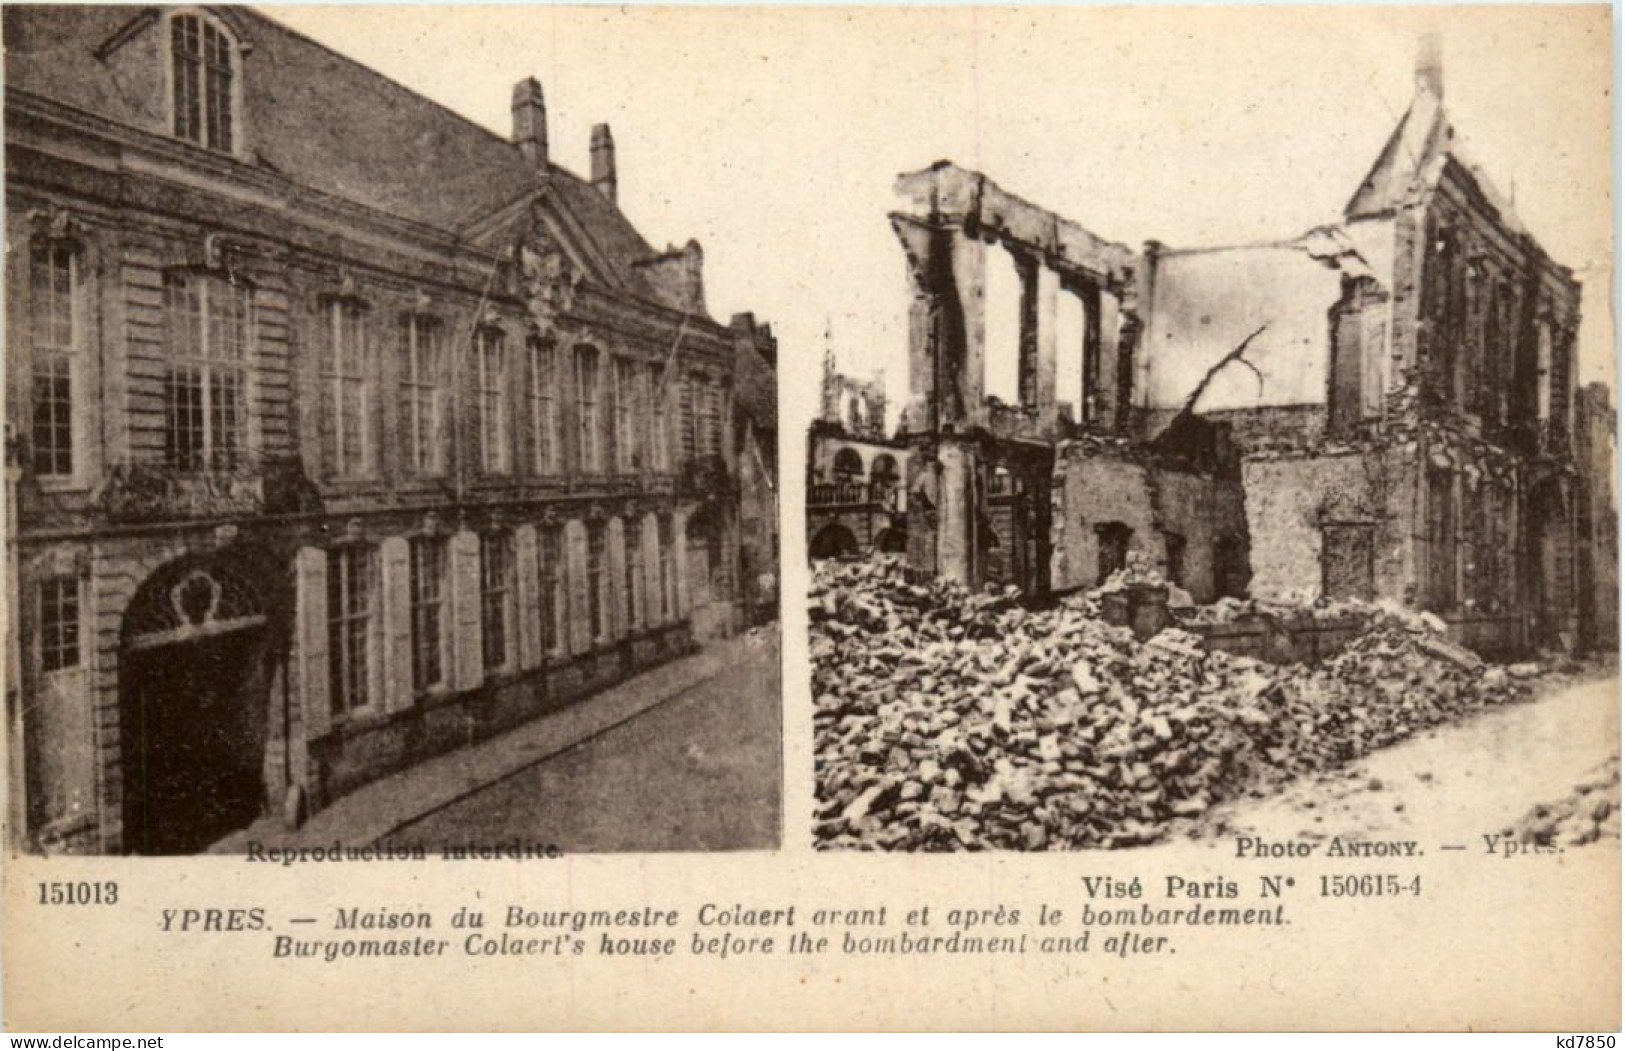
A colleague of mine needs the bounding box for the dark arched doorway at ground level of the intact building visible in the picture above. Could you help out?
[119,551,283,854]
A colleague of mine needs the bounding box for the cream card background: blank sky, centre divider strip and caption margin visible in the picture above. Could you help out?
[3,6,1620,1032]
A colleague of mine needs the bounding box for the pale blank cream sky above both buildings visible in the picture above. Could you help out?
[267,5,1615,422]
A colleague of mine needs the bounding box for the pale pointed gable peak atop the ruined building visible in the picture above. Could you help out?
[1344,83,1523,231]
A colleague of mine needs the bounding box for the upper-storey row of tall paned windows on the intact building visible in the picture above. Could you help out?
[19,238,725,479]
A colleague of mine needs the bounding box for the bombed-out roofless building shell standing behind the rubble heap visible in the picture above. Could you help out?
[845,45,1617,651]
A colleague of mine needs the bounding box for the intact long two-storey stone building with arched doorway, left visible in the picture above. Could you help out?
[3,6,777,853]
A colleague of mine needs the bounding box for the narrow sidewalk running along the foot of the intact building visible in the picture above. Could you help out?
[208,624,778,854]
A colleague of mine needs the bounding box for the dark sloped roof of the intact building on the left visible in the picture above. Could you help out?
[3,5,676,297]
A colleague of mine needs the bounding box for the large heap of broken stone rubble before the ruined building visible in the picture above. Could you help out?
[809,562,1523,850]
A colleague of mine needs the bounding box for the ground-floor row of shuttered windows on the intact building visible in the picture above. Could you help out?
[327,515,678,716]
